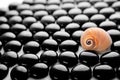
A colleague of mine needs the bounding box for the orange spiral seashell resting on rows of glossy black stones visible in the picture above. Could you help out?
[80,28,112,53]
